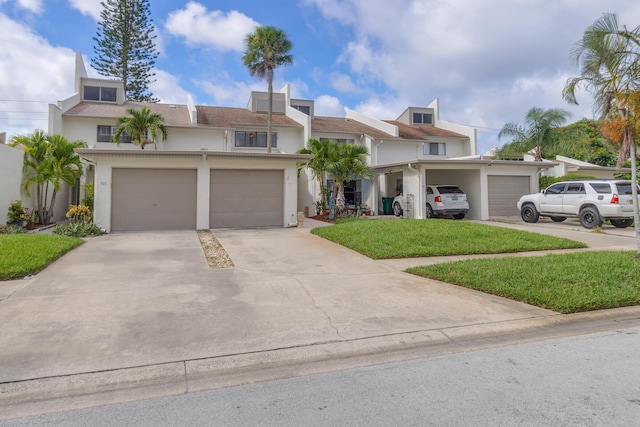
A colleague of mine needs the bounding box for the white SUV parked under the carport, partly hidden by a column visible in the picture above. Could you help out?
[393,185,469,219]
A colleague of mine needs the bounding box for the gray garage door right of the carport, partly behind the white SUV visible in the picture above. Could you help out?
[487,175,531,218]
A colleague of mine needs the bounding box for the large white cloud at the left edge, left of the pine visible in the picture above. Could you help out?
[0,13,75,138]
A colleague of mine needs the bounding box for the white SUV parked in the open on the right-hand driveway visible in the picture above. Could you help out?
[518,180,633,228]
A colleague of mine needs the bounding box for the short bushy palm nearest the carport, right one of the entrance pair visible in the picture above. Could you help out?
[327,143,373,211]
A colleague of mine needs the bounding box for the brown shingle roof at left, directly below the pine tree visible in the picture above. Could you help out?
[63,101,192,127]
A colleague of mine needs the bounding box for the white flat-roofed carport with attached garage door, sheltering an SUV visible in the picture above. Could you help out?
[375,158,553,220]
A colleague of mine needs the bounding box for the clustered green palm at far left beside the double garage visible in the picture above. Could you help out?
[9,130,86,224]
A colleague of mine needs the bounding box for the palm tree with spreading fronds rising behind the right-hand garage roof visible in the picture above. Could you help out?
[498,107,586,162]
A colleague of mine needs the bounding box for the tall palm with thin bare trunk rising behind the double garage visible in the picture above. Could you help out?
[242,26,293,153]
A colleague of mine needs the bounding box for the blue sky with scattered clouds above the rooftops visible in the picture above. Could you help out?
[0,0,640,154]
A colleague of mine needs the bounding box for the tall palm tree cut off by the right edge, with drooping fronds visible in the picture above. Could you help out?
[562,13,640,258]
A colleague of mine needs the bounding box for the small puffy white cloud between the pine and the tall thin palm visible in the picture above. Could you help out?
[166,1,259,51]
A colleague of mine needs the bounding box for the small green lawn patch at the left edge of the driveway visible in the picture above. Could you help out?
[0,234,84,280]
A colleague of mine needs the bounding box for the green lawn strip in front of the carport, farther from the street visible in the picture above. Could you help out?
[311,219,586,259]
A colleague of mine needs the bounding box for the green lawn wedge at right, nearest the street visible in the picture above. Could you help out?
[407,251,640,313]
